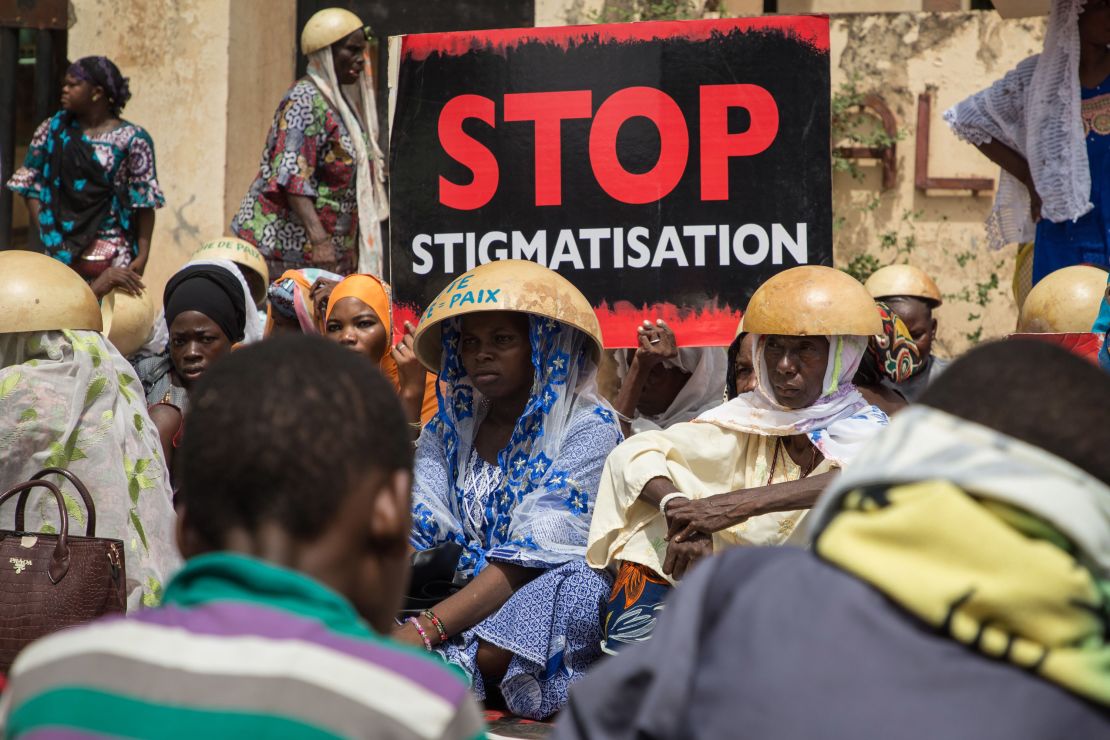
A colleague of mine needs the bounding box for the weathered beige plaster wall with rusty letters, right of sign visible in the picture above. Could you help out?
[831,12,1043,355]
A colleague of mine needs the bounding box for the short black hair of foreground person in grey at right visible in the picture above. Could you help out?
[920,339,1110,483]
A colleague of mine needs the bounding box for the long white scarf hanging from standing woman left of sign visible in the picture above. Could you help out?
[309,47,390,278]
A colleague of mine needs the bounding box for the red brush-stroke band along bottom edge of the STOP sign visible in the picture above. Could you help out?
[393,301,743,349]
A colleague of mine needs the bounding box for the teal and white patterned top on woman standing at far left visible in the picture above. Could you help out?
[8,111,165,266]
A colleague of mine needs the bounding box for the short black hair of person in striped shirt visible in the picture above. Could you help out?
[179,334,413,548]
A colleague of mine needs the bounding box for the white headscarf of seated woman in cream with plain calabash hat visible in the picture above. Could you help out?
[694,334,888,464]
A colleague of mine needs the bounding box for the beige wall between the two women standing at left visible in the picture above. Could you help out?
[69,0,296,294]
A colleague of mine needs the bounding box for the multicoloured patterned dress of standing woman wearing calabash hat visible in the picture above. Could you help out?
[231,79,361,278]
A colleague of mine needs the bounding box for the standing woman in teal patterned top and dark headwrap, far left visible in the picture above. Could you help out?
[8,57,165,298]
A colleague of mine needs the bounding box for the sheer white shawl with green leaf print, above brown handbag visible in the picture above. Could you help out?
[0,330,181,610]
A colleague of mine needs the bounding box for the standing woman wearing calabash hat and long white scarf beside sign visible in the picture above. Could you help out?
[231,8,389,281]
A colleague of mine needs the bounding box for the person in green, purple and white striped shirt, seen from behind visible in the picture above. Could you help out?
[0,336,484,740]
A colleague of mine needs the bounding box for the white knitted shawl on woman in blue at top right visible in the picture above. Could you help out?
[945,0,1093,249]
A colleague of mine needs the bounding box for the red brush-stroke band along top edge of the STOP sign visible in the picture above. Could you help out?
[401,16,829,61]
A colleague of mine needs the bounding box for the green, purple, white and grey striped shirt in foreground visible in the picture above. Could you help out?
[0,553,484,740]
